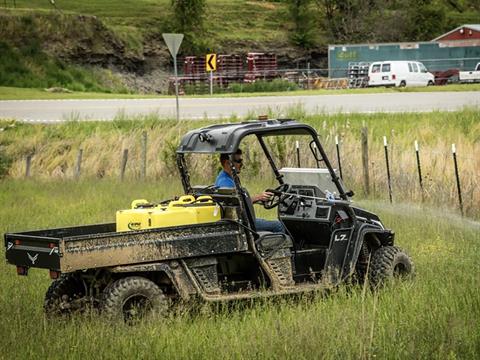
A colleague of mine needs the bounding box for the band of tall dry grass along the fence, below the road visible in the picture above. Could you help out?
[0,108,480,219]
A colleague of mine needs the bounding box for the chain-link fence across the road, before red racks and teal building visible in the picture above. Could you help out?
[162,57,480,94]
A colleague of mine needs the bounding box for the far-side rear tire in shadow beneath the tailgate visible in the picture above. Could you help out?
[43,274,85,316]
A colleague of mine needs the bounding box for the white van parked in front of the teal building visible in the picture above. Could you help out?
[368,61,435,87]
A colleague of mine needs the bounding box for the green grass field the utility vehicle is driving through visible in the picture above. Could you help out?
[0,180,480,359]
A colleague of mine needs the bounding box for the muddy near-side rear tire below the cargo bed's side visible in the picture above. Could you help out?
[101,276,168,322]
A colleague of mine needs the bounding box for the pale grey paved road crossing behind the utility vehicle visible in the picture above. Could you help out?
[0,91,480,122]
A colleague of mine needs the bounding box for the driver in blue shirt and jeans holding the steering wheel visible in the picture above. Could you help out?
[215,149,285,233]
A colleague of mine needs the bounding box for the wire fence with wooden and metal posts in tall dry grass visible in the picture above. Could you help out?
[18,127,480,217]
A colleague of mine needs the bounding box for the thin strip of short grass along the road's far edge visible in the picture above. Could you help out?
[0,83,480,100]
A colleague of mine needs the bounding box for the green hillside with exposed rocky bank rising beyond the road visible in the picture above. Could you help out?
[0,0,480,92]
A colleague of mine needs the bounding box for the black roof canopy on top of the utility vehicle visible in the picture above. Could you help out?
[177,119,317,154]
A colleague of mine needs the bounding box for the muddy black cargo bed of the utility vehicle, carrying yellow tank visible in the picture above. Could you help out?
[5,220,248,273]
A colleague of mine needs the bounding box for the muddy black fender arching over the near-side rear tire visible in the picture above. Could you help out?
[109,261,197,300]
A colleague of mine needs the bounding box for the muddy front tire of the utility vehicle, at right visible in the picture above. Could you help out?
[369,246,415,288]
